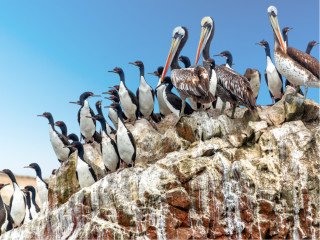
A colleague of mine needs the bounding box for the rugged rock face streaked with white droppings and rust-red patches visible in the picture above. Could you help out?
[1,96,320,239]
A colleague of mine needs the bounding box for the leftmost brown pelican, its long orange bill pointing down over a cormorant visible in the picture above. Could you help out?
[161,27,215,118]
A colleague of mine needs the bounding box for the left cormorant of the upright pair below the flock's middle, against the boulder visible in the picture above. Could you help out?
[90,114,120,173]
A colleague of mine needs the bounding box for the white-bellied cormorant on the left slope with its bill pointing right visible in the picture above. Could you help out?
[70,92,101,143]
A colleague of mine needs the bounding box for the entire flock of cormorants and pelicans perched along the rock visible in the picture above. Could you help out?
[0,6,320,233]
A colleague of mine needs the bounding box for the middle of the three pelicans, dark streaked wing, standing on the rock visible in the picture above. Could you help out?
[195,17,255,118]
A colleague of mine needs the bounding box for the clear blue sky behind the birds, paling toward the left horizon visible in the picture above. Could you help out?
[0,0,319,177]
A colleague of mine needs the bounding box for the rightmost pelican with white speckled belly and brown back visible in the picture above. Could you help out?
[268,6,320,97]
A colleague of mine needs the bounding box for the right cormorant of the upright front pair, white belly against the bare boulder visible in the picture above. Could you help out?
[108,103,136,167]
